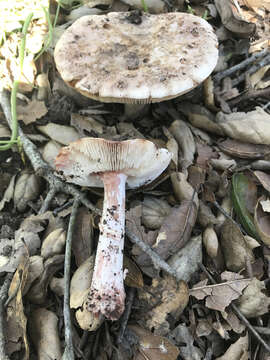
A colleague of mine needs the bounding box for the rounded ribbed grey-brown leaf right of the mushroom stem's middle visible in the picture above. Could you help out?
[142,196,171,229]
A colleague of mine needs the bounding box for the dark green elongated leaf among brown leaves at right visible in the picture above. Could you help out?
[232,173,260,239]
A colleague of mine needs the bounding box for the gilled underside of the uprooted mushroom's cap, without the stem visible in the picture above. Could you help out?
[55,138,172,188]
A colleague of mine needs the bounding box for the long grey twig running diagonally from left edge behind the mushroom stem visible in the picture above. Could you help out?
[0,90,177,279]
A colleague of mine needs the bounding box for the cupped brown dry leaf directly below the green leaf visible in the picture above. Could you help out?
[220,219,254,271]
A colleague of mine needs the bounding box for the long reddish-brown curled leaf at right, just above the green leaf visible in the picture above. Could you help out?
[218,139,270,159]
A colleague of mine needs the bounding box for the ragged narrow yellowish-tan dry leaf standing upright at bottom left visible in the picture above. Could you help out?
[7,254,29,360]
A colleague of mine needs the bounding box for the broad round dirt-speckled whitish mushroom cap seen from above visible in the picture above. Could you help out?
[55,12,218,103]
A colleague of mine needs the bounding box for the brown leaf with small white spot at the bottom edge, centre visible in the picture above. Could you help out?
[128,325,179,360]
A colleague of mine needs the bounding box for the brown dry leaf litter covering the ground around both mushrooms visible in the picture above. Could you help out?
[0,0,270,360]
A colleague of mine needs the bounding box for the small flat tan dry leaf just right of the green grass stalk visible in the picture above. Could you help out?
[17,99,48,125]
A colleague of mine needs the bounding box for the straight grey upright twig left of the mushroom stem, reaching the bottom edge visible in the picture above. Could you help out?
[62,199,80,360]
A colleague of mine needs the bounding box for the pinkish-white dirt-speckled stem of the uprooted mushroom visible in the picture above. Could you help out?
[87,172,127,320]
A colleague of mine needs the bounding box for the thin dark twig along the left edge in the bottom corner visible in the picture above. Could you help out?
[0,273,13,360]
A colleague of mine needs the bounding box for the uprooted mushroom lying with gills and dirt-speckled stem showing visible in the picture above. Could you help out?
[55,138,171,320]
